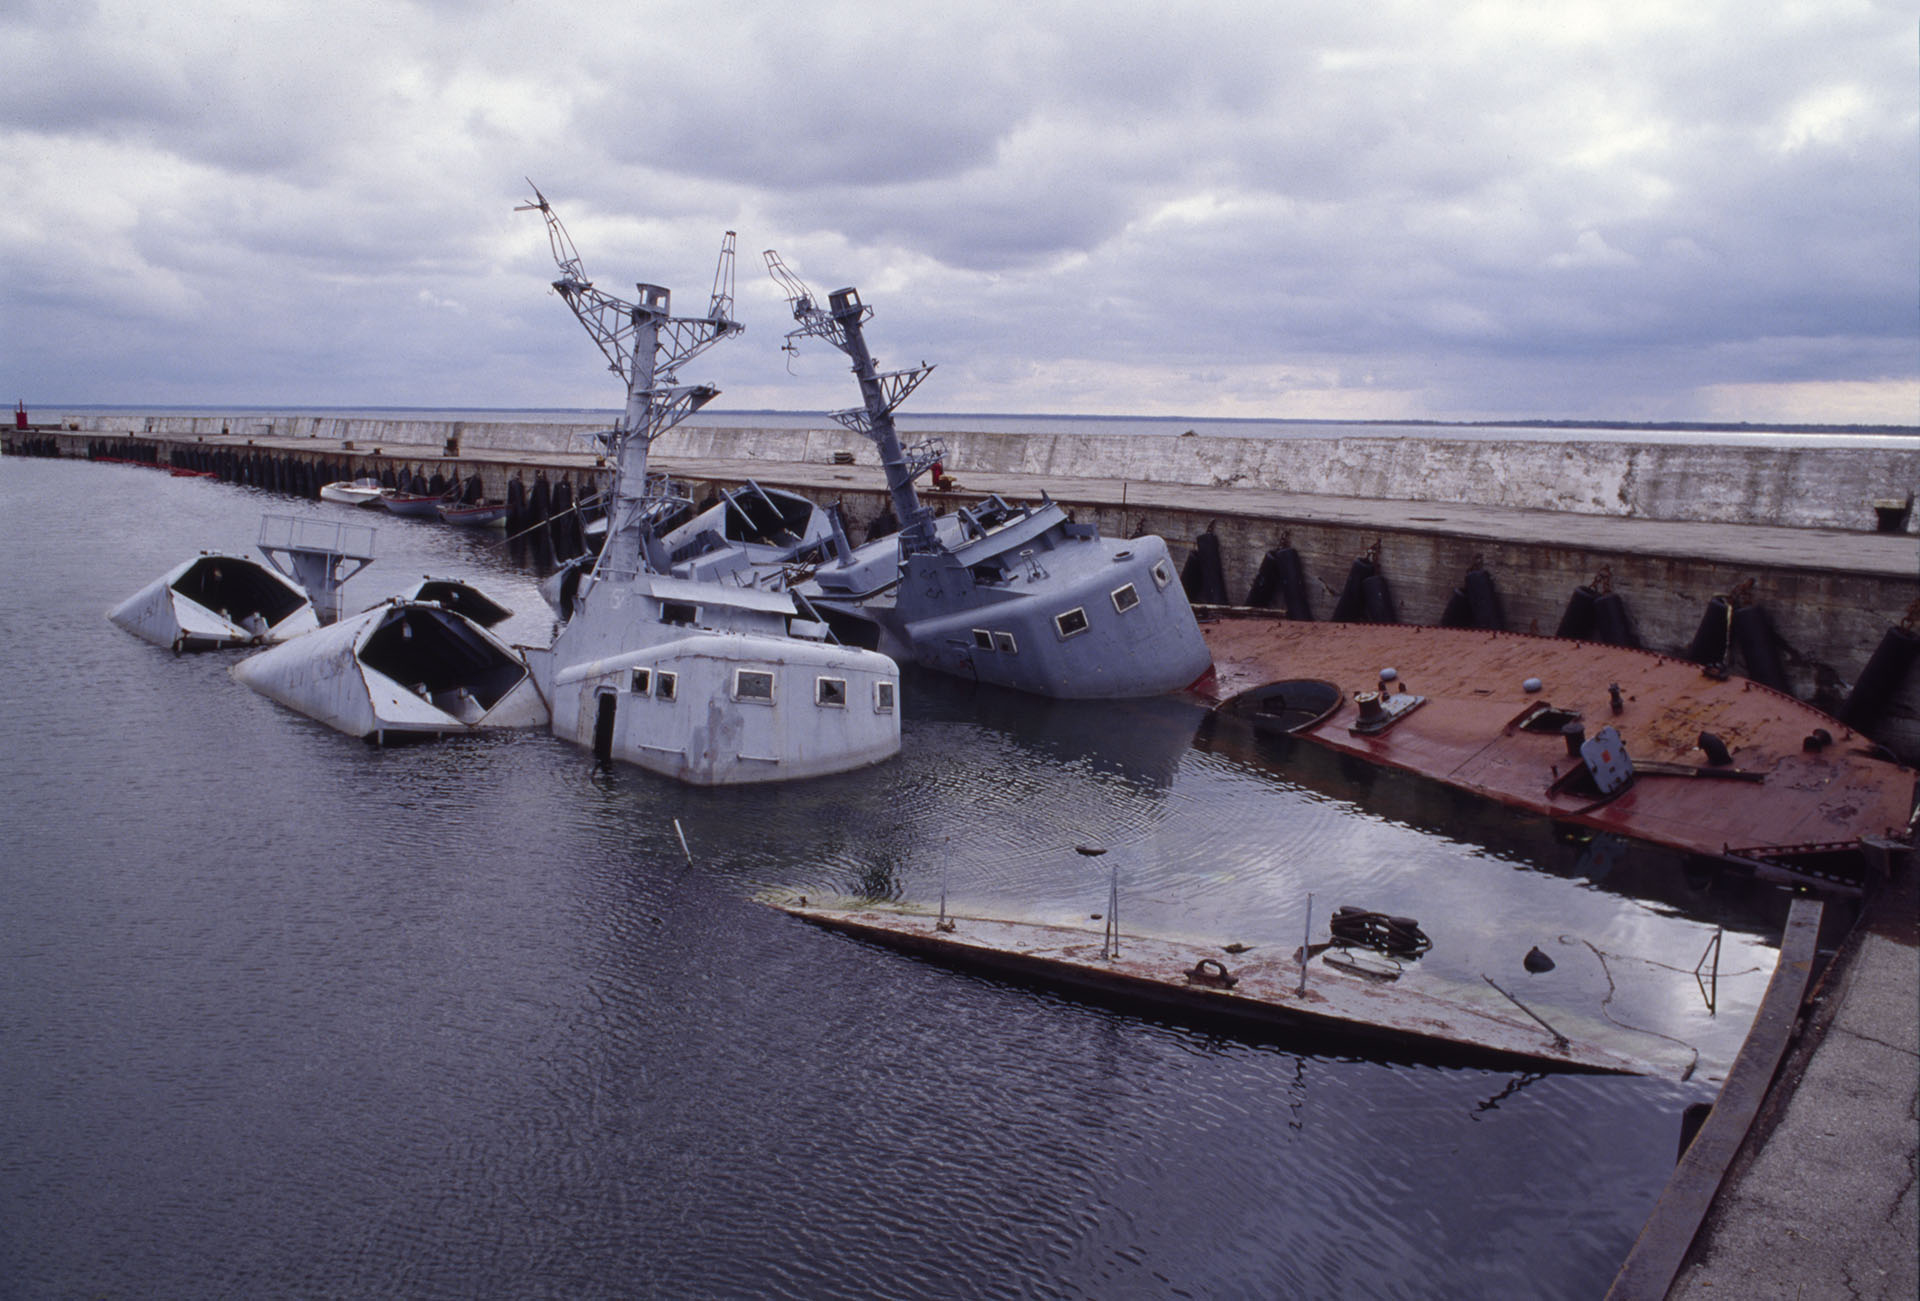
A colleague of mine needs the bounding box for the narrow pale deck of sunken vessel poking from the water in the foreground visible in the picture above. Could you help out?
[770,900,1682,1075]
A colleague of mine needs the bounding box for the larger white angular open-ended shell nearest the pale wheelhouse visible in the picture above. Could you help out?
[232,601,549,745]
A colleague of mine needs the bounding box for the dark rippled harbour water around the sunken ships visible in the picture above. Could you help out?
[0,459,1784,1297]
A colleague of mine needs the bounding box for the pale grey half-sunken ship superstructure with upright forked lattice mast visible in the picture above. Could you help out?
[526,190,900,785]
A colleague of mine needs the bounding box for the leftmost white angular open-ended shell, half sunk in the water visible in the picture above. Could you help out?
[108,551,321,654]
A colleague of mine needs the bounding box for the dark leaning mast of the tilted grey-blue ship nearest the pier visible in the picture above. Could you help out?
[766,249,945,553]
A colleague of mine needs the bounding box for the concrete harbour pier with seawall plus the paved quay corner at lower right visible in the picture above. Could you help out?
[15,404,1920,1297]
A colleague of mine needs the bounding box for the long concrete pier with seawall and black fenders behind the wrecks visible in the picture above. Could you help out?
[8,413,1920,762]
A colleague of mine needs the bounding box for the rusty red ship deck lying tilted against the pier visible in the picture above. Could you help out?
[1198,618,1914,871]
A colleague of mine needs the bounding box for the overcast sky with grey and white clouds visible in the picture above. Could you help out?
[0,0,1920,424]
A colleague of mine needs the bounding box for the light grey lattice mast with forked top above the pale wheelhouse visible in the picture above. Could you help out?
[515,180,745,574]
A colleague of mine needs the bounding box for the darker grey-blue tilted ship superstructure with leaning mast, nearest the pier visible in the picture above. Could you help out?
[766,249,1213,698]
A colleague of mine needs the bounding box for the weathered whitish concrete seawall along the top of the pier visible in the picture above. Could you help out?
[56,416,1920,532]
